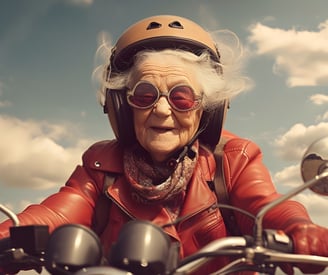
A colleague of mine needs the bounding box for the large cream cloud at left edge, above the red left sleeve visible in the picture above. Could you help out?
[0,116,90,189]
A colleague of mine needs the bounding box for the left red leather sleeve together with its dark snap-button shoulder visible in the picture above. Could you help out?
[0,140,123,238]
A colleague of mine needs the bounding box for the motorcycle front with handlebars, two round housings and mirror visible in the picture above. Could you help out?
[0,137,328,275]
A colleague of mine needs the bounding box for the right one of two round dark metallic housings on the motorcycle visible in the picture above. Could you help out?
[108,221,178,275]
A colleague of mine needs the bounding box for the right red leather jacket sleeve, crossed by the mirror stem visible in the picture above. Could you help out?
[224,138,311,234]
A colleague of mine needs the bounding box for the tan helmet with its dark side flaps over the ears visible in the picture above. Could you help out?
[104,15,227,151]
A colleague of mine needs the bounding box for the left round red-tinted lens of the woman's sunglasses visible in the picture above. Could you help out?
[129,83,158,108]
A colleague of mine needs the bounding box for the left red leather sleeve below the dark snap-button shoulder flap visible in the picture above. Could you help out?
[0,166,99,238]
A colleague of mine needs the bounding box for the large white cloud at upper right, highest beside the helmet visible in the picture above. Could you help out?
[249,20,328,87]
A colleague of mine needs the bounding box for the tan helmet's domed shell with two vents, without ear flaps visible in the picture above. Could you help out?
[111,15,220,71]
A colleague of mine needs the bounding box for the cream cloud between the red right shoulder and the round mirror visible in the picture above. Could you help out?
[274,122,328,162]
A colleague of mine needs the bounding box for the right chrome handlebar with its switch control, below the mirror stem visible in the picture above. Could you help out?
[173,234,328,275]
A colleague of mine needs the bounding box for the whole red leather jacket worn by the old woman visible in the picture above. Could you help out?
[0,131,310,274]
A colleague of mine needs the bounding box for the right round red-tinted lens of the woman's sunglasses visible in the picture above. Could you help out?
[169,86,198,110]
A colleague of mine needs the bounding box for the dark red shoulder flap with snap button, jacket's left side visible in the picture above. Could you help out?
[82,140,123,173]
